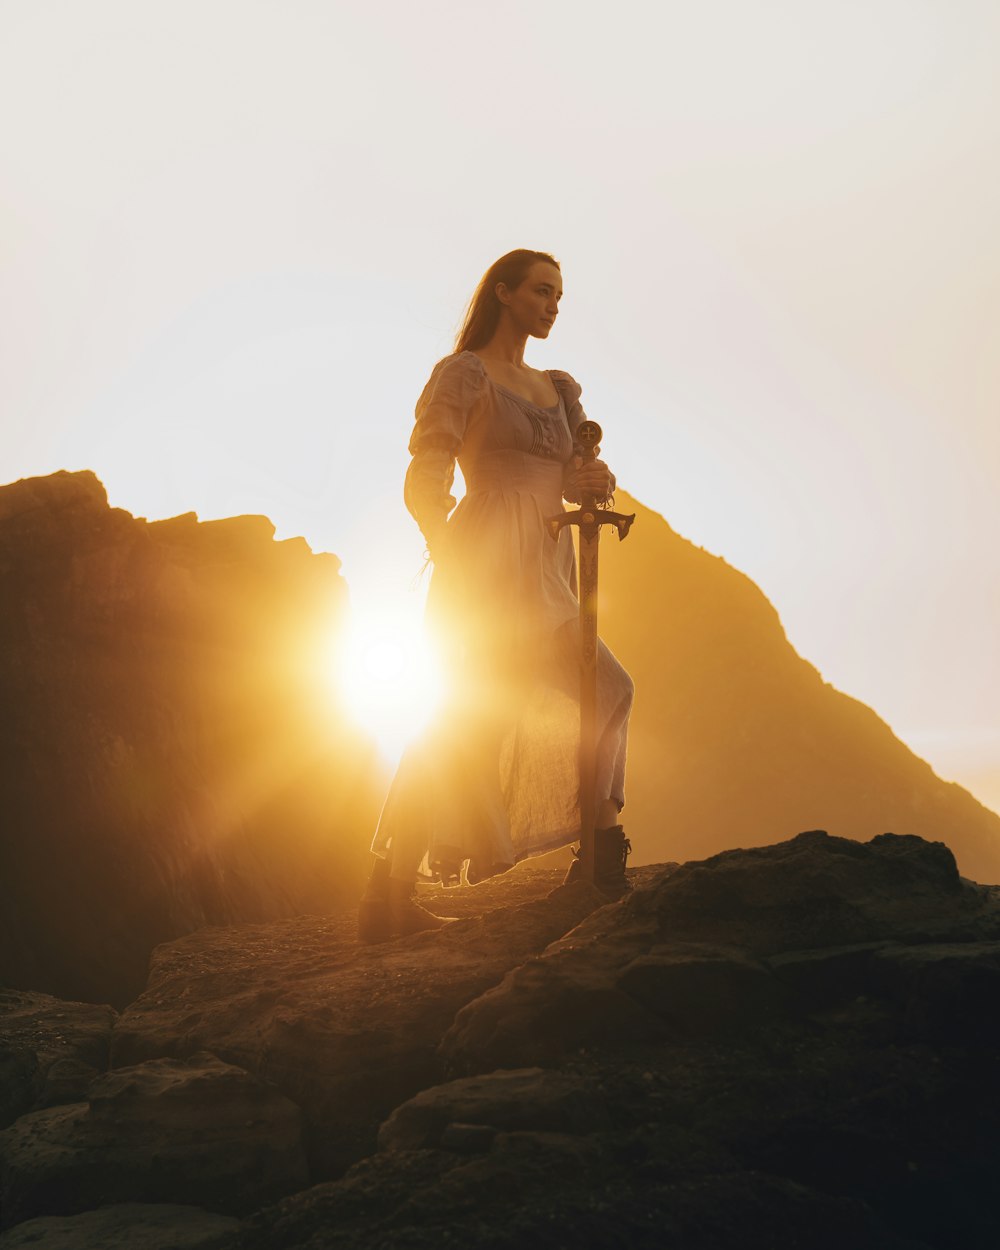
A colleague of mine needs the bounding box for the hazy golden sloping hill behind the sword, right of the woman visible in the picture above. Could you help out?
[600,493,1000,881]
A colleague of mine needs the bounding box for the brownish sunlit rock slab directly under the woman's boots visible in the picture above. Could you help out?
[113,864,606,1176]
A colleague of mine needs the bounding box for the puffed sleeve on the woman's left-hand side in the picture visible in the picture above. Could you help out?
[403,351,484,553]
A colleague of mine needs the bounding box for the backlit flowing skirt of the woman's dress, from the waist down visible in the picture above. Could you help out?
[373,453,634,878]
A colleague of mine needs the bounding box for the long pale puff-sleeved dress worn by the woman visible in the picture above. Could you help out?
[373,351,633,878]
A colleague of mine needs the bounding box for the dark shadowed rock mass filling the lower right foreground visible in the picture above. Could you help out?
[238,833,1000,1250]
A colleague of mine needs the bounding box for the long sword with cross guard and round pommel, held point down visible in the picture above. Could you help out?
[545,421,635,883]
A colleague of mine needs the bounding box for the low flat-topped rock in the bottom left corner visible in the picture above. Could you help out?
[0,1203,240,1250]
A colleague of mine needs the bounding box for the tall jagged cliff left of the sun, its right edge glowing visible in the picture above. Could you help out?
[0,473,381,1005]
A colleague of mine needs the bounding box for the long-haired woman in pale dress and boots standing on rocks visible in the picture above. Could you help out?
[359,249,633,941]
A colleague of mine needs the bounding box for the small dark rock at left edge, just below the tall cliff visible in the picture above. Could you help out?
[0,989,118,1128]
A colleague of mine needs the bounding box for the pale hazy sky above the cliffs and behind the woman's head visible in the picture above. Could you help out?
[0,0,1000,808]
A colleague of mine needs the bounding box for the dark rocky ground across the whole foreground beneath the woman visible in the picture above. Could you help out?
[0,833,1000,1250]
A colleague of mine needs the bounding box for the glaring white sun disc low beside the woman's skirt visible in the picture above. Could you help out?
[333,610,443,764]
